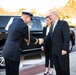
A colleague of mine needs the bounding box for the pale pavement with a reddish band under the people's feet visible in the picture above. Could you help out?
[0,52,76,75]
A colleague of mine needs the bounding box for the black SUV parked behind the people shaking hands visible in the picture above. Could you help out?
[0,15,75,67]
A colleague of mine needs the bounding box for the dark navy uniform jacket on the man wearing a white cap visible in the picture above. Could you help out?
[1,19,36,62]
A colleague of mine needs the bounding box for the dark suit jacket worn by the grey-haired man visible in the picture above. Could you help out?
[44,20,70,55]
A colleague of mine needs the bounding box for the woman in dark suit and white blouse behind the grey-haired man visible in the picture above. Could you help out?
[41,16,53,75]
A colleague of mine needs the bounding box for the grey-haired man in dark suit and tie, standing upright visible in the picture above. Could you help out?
[44,11,70,75]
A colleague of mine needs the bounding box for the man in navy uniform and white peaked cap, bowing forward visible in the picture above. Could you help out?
[2,11,42,75]
